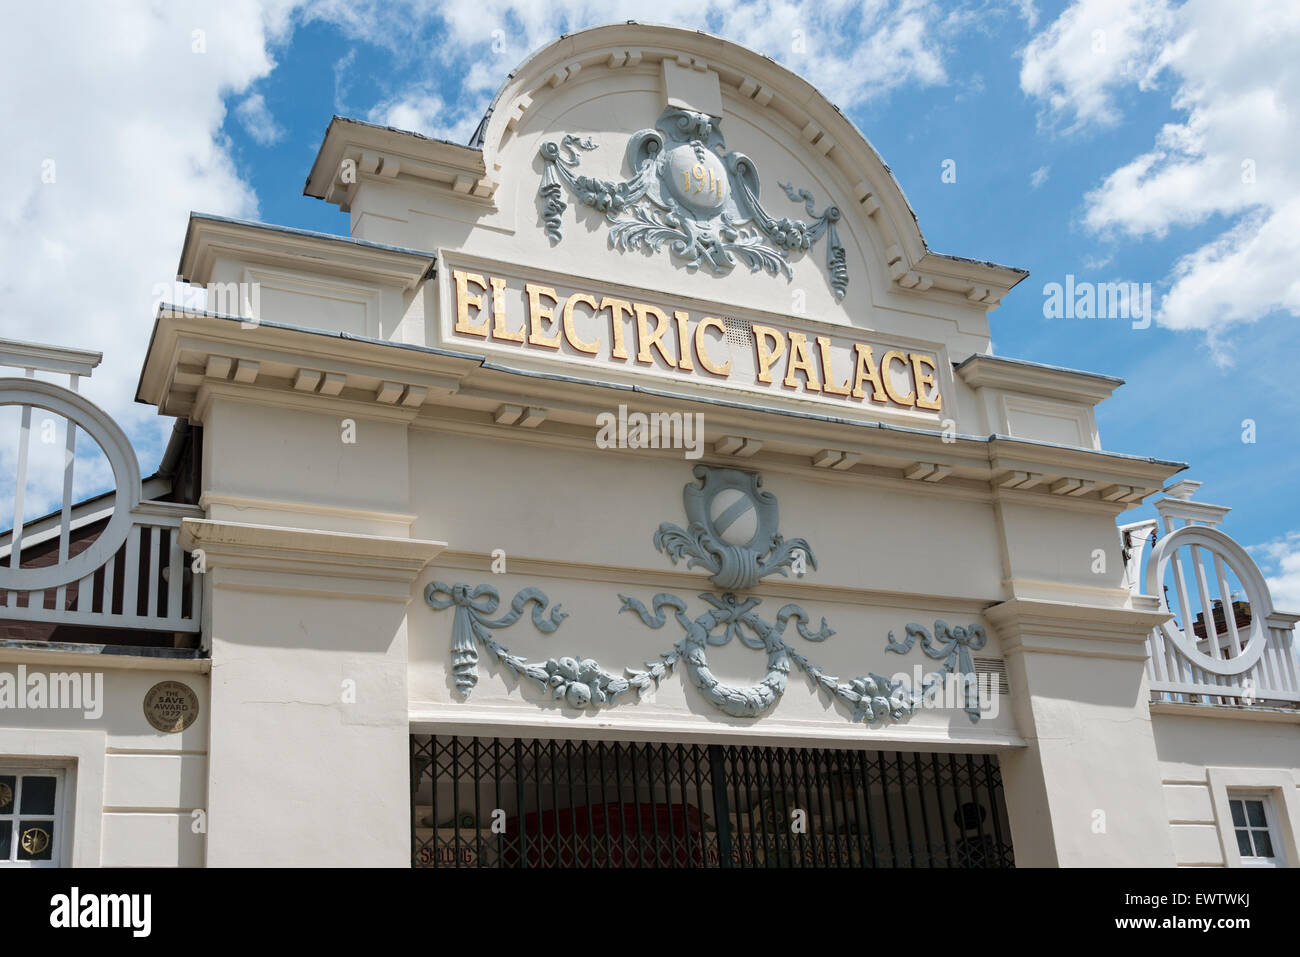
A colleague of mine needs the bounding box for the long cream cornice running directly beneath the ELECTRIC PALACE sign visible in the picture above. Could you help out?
[137,308,1186,516]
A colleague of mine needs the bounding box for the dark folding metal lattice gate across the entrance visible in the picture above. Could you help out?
[411,735,1014,867]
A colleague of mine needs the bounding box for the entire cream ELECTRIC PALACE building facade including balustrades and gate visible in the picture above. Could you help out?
[0,23,1300,866]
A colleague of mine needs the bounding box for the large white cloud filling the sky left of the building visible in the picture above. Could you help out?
[0,0,297,514]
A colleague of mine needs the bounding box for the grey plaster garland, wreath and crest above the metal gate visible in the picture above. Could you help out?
[424,465,985,723]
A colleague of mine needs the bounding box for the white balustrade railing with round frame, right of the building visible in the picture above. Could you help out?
[1121,482,1300,706]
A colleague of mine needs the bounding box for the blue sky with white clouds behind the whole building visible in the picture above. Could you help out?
[0,0,1300,610]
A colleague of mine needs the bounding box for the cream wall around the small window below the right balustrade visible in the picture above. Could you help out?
[1152,705,1300,867]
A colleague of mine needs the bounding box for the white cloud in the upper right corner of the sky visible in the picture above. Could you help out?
[1021,0,1300,363]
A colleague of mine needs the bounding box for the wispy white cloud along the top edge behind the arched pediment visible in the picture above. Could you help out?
[303,0,961,130]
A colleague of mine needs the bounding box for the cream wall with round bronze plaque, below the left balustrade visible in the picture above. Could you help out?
[0,651,211,867]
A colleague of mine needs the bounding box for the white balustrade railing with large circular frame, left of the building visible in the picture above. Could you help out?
[0,339,203,632]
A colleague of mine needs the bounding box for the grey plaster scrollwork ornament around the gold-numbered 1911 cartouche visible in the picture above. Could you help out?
[538,107,849,299]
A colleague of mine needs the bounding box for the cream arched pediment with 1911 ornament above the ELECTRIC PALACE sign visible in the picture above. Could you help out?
[475,23,1024,315]
